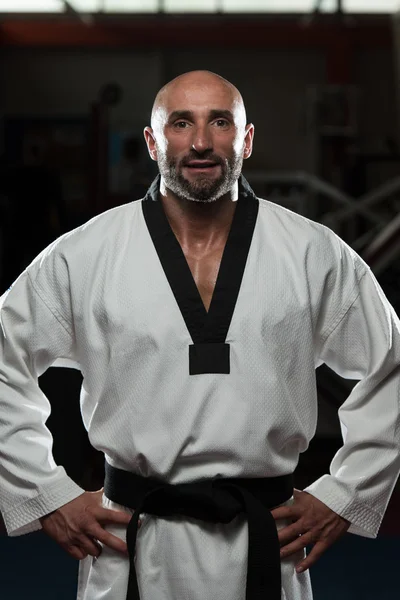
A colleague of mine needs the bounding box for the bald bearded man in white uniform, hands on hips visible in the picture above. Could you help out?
[0,71,400,600]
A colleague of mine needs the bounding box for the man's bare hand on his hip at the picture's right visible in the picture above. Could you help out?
[271,490,350,573]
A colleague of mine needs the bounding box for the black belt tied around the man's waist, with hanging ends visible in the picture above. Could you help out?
[104,462,293,600]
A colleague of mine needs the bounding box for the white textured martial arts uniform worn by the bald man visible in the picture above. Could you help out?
[0,178,400,600]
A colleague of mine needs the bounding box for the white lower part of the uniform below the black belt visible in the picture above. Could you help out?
[77,498,312,600]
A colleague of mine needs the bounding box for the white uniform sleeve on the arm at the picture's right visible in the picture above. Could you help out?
[306,269,400,537]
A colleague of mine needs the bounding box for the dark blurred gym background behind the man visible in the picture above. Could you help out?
[0,0,400,600]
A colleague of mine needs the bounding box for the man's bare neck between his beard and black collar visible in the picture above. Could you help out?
[160,178,239,253]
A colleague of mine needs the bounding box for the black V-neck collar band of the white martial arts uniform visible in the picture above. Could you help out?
[142,171,259,374]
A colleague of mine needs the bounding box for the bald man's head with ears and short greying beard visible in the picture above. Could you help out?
[145,77,254,202]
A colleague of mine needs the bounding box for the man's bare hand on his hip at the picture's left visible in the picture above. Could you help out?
[40,490,131,560]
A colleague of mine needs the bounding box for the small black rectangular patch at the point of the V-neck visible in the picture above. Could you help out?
[189,342,230,375]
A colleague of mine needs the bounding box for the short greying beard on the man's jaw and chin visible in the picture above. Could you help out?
[158,152,243,203]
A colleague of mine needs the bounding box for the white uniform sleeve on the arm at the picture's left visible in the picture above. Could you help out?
[0,271,84,535]
